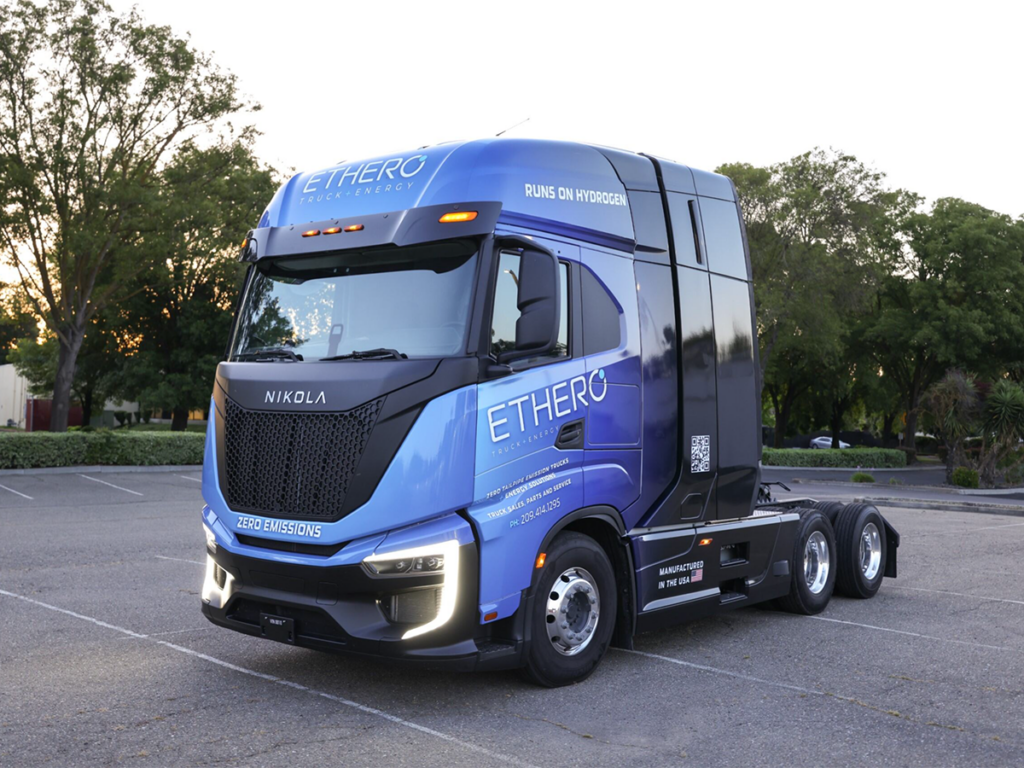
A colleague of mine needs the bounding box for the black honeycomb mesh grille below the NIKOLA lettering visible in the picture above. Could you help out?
[224,397,384,520]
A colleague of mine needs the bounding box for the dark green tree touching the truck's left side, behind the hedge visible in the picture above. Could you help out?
[116,133,276,430]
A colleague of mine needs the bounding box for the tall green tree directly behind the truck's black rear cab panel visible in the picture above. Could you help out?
[718,150,916,447]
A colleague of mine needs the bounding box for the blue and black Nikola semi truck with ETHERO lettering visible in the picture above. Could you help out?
[202,138,899,686]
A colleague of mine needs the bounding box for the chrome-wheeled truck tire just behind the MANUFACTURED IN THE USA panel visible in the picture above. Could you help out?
[778,509,836,616]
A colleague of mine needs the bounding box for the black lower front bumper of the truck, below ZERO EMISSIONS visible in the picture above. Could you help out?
[203,543,521,671]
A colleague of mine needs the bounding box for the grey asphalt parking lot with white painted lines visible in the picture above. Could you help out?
[0,471,1024,767]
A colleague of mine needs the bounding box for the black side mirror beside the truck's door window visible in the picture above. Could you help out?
[498,245,561,364]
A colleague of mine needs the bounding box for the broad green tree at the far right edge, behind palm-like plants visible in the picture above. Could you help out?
[865,199,1024,451]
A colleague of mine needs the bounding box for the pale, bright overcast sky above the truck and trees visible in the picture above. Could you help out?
[96,0,1024,216]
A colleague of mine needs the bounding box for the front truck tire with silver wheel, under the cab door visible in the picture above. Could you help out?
[523,531,617,688]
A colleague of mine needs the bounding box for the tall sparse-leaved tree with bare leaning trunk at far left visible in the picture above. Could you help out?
[0,0,242,431]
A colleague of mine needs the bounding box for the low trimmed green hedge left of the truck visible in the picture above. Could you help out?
[0,430,206,469]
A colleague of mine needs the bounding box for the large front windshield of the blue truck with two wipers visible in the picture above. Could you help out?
[229,241,476,360]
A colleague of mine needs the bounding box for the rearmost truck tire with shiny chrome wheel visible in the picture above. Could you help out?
[836,504,887,600]
